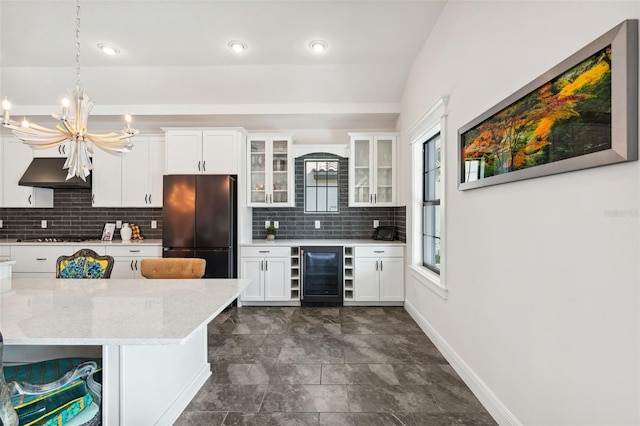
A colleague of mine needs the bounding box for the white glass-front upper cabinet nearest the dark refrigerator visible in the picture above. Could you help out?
[247,135,294,207]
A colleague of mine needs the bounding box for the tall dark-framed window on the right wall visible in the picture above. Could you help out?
[422,133,442,274]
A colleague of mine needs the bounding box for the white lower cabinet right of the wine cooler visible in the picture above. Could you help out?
[353,246,404,302]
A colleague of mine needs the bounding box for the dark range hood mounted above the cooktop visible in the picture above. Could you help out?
[18,158,91,189]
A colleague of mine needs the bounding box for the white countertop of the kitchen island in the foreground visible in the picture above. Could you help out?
[0,278,251,345]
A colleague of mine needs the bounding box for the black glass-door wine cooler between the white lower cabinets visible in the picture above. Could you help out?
[300,246,343,306]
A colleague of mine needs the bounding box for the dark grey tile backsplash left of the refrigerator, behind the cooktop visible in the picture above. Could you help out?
[0,189,162,239]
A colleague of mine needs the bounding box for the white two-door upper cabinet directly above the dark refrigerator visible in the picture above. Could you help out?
[165,129,243,175]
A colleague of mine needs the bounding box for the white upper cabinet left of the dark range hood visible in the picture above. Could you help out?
[0,137,53,207]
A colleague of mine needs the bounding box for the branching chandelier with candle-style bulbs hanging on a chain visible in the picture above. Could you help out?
[2,0,138,180]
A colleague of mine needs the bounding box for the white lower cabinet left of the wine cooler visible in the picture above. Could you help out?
[240,247,291,302]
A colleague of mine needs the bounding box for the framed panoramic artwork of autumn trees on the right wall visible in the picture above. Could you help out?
[458,19,638,190]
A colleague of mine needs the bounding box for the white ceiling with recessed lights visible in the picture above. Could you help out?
[0,0,446,130]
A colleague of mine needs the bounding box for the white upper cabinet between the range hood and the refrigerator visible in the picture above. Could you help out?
[92,136,165,207]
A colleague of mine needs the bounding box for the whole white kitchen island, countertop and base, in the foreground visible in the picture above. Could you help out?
[0,278,250,425]
